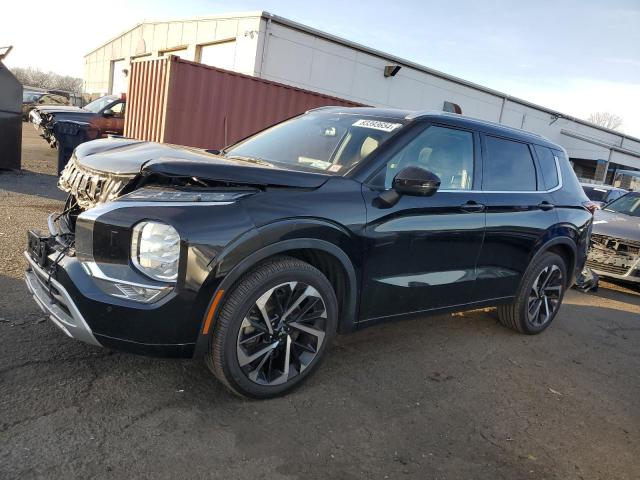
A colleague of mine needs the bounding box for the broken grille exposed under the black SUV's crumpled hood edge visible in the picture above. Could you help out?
[58,156,134,210]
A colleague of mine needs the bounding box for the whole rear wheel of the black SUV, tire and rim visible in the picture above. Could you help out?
[498,252,567,335]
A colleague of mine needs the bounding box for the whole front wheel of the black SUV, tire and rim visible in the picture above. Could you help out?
[206,257,338,398]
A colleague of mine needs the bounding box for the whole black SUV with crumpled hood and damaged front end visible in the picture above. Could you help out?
[26,107,592,398]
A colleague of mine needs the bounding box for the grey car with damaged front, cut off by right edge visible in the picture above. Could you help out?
[587,192,640,284]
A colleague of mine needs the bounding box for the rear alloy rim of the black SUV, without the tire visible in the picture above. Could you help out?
[527,265,563,327]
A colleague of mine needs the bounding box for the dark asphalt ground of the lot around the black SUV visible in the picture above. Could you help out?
[0,126,640,479]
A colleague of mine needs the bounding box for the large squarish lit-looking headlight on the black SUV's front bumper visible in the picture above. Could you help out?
[131,221,180,282]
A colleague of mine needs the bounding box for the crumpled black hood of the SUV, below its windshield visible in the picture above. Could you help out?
[75,138,330,188]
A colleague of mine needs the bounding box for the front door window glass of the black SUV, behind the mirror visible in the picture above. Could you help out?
[384,126,473,190]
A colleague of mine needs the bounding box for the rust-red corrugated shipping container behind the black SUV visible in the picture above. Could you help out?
[124,56,360,148]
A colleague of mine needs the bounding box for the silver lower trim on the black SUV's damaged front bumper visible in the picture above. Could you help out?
[24,252,102,347]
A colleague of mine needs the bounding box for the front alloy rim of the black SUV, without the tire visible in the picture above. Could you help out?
[236,282,327,385]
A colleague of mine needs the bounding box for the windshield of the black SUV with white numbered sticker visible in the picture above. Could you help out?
[224,112,406,175]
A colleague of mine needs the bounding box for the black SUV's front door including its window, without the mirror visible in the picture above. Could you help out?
[361,125,485,320]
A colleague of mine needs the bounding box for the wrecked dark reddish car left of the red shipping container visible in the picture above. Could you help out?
[29,95,126,148]
